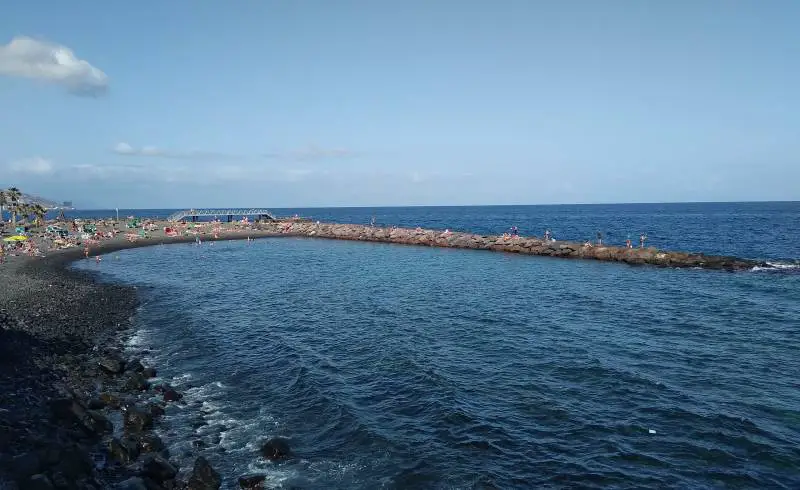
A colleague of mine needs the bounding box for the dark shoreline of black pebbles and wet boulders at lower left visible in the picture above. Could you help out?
[0,253,231,490]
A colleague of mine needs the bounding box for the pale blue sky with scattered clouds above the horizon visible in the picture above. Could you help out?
[0,0,800,208]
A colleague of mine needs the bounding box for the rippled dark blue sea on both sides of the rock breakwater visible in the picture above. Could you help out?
[76,203,800,489]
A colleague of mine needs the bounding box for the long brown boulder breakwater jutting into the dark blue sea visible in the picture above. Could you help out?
[262,221,766,271]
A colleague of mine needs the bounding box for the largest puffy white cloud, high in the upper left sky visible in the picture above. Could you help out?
[0,37,108,95]
